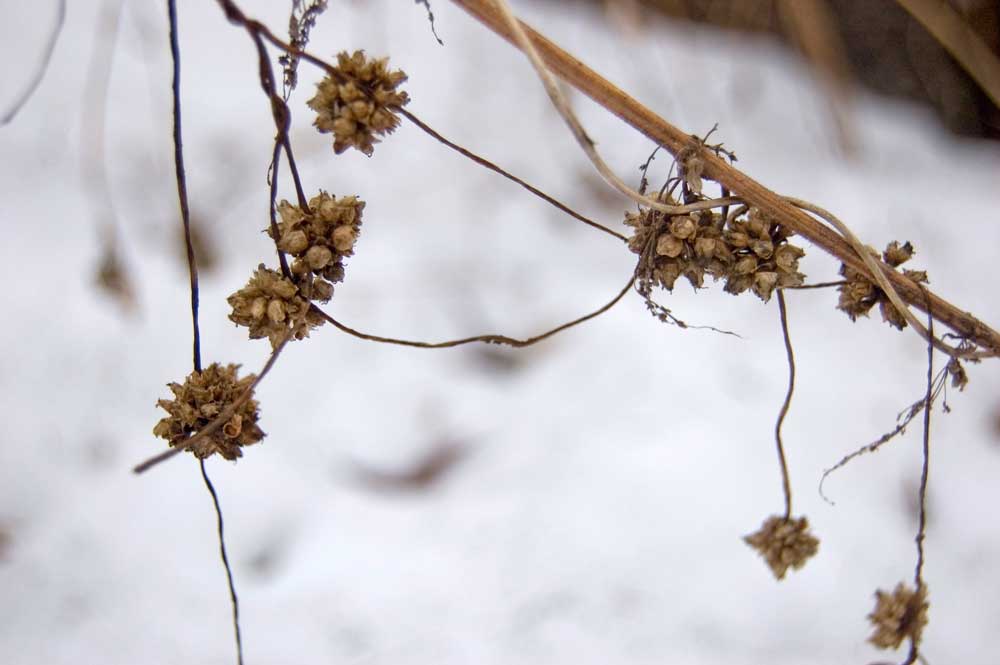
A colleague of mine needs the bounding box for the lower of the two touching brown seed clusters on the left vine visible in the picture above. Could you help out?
[228,264,323,347]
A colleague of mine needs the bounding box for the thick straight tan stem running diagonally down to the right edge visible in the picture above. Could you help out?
[452,0,1000,356]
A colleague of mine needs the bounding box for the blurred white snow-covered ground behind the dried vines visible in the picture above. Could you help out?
[0,0,1000,665]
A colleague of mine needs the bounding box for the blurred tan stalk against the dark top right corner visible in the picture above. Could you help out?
[896,0,1000,108]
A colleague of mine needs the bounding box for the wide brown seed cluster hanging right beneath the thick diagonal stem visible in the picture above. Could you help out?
[625,202,805,302]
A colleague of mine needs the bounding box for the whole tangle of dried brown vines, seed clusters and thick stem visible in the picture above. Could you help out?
[113,0,1000,663]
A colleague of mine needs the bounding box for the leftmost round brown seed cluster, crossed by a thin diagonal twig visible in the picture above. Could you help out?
[153,363,264,460]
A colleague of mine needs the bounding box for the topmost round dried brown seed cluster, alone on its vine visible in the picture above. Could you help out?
[307,51,410,157]
